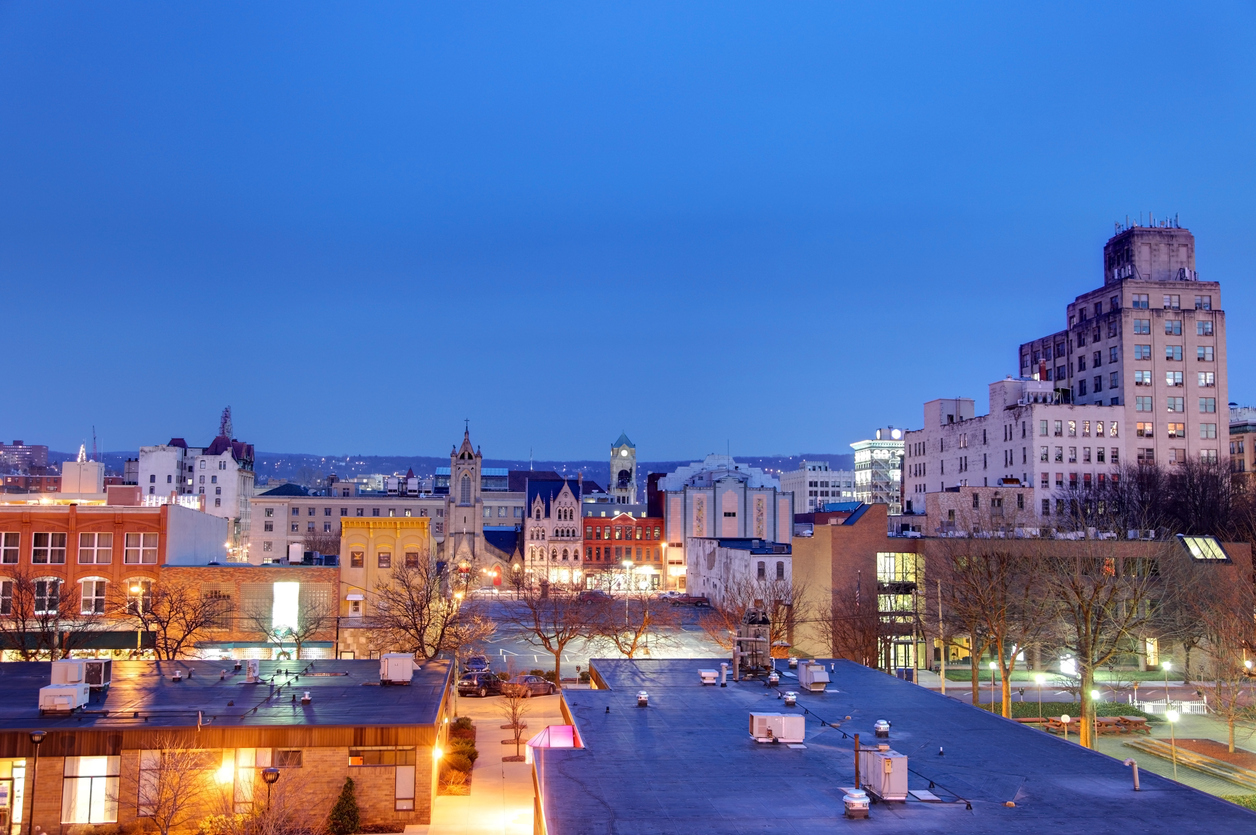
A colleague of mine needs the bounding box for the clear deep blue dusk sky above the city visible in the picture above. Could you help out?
[0,3,1256,458]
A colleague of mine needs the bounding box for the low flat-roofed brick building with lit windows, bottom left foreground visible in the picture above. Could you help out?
[0,660,450,832]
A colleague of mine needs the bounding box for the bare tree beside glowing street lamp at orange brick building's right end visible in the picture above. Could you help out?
[109,579,231,660]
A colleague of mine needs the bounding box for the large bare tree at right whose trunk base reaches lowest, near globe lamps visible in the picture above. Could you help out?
[1036,540,1171,747]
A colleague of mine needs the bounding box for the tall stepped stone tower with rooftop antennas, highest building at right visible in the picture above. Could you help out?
[1019,221,1230,465]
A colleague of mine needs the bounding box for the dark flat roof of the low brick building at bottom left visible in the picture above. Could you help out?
[0,659,450,731]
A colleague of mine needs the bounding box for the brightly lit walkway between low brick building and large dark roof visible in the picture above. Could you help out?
[424,696,563,835]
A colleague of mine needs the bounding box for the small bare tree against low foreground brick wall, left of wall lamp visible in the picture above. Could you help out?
[127,732,222,835]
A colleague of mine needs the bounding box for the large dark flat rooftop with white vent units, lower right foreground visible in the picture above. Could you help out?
[536,658,1256,835]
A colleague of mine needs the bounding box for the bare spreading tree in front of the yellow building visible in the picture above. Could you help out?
[371,559,496,659]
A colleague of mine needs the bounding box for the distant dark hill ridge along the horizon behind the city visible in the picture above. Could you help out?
[48,451,854,487]
